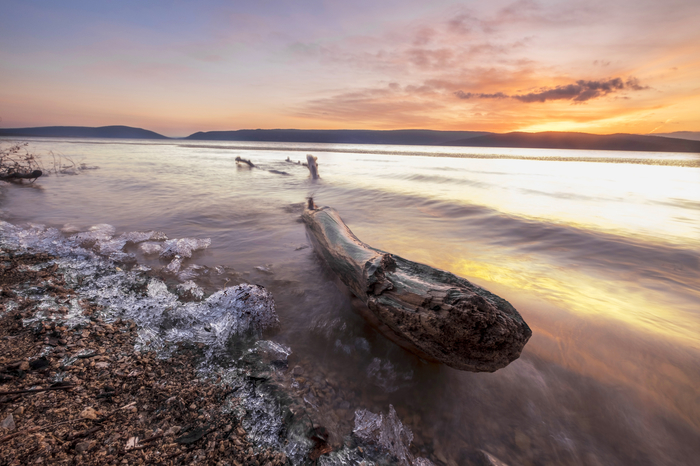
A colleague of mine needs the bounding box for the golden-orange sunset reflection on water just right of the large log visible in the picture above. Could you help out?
[445,259,700,429]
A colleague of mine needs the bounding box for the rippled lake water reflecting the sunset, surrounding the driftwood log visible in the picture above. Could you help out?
[0,139,700,466]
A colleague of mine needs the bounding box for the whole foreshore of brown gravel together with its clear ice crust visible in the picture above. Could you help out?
[0,221,440,466]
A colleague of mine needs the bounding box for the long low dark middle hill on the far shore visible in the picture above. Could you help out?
[185,129,491,145]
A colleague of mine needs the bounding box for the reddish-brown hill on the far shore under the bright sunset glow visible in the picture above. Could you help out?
[445,132,700,153]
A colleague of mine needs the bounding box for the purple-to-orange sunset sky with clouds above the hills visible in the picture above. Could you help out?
[0,0,700,136]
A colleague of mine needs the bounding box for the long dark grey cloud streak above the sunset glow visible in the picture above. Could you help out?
[454,77,649,103]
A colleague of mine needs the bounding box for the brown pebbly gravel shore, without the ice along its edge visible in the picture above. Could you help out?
[0,251,287,465]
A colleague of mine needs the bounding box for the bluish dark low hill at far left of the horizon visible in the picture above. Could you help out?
[0,126,168,139]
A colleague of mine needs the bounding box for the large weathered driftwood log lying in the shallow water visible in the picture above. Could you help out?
[302,205,532,372]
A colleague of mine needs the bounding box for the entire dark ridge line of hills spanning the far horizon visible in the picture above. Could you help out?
[0,126,700,153]
